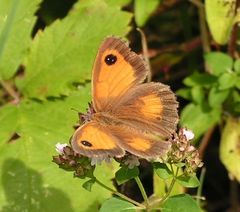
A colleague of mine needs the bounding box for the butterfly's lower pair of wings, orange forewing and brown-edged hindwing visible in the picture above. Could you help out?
[71,121,170,159]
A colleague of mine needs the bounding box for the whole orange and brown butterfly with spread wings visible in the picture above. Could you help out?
[71,36,178,159]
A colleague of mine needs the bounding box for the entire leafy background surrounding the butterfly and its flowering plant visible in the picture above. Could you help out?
[0,0,240,211]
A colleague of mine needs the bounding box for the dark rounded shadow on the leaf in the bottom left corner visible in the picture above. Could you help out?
[0,159,73,212]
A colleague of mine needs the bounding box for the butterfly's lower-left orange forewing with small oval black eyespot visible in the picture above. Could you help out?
[71,121,125,158]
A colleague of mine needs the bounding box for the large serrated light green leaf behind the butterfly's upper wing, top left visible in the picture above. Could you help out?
[17,0,131,98]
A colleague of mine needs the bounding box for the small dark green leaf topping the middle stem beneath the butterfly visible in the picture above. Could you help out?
[115,166,139,185]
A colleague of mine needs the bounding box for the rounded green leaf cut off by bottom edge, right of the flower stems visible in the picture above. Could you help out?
[161,194,201,212]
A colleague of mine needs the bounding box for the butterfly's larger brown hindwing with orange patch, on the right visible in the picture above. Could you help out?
[114,83,178,137]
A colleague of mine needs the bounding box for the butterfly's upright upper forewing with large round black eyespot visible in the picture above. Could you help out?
[92,37,147,112]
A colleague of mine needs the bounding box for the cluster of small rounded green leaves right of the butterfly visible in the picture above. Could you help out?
[178,52,240,138]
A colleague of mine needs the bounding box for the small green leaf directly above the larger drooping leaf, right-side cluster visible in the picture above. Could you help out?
[208,86,230,108]
